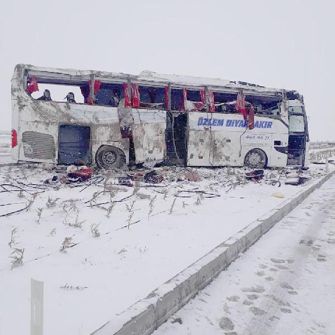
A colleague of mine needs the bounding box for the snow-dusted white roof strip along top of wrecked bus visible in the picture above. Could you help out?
[17,64,283,94]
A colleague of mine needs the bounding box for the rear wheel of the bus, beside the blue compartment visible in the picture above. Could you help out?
[95,145,126,170]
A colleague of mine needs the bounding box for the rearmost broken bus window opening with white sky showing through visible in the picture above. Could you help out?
[31,83,84,103]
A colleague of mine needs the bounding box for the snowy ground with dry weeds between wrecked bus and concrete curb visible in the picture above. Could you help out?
[0,166,334,334]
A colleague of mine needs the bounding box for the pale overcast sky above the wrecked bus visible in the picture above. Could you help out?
[0,0,335,140]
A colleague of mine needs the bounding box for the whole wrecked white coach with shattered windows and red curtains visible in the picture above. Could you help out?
[12,64,309,169]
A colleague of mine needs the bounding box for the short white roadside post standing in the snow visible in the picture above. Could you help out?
[30,279,44,335]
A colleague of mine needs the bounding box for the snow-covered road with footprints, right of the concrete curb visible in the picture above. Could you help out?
[154,177,335,335]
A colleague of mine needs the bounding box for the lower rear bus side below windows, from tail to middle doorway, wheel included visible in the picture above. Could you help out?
[12,101,166,169]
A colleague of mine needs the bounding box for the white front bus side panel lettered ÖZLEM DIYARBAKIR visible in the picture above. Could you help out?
[187,112,288,167]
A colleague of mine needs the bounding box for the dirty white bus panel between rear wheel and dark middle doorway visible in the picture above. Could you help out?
[132,109,166,163]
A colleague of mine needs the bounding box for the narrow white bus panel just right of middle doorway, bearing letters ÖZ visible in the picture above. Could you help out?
[187,112,212,166]
